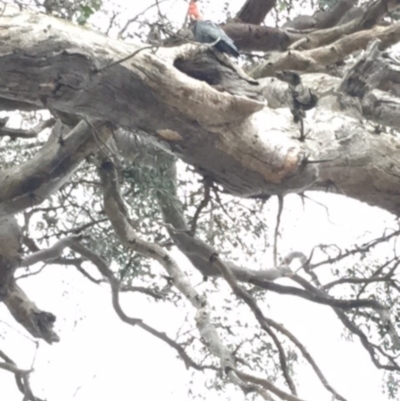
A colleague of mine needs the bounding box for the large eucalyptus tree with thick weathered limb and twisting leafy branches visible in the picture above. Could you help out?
[0,0,400,401]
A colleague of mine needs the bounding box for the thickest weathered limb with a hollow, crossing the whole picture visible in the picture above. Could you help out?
[0,8,399,213]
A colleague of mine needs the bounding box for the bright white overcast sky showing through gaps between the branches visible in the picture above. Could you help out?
[0,0,394,401]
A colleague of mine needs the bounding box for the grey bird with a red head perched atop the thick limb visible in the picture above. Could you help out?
[188,0,239,57]
